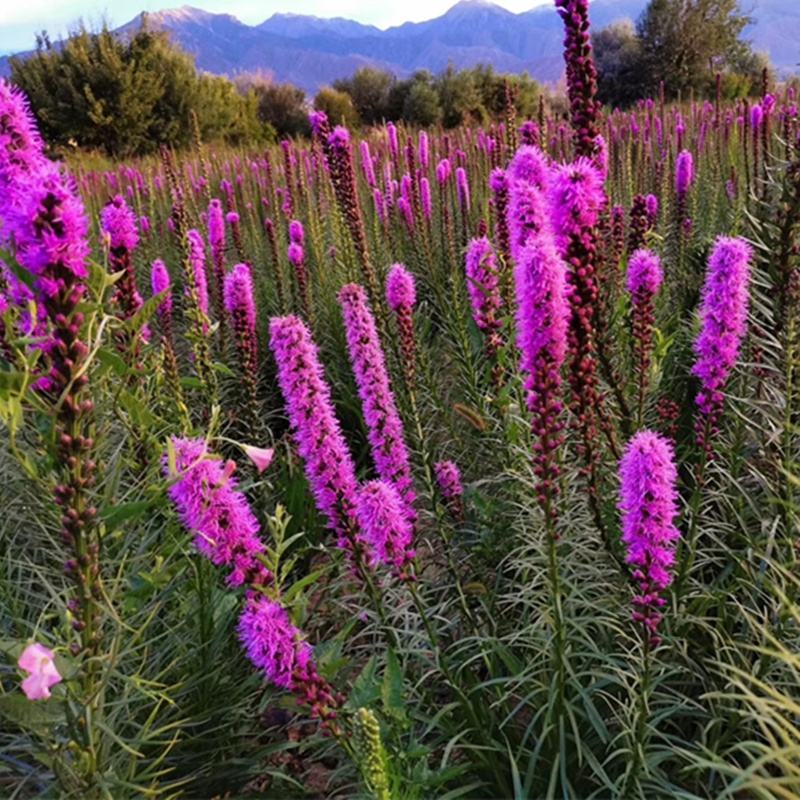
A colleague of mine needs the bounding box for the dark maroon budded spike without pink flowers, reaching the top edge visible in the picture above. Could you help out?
[555,0,600,156]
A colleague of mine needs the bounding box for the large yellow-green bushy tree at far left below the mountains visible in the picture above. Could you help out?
[10,19,263,156]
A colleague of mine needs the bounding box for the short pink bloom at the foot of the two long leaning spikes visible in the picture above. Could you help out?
[356,481,415,578]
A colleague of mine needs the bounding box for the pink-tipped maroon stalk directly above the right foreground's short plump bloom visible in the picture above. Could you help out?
[626,250,664,426]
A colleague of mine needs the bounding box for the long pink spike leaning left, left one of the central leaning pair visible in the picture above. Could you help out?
[269,316,358,550]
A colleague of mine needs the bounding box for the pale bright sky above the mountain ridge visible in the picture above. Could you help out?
[0,0,548,53]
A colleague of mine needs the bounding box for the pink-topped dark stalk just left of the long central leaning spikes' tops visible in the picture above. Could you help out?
[223,264,261,431]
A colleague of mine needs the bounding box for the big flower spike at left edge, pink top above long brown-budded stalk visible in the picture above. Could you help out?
[0,155,100,655]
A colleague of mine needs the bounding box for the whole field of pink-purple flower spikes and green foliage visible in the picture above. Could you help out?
[0,0,800,800]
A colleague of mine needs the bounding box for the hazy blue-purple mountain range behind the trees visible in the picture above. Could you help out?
[0,0,800,93]
